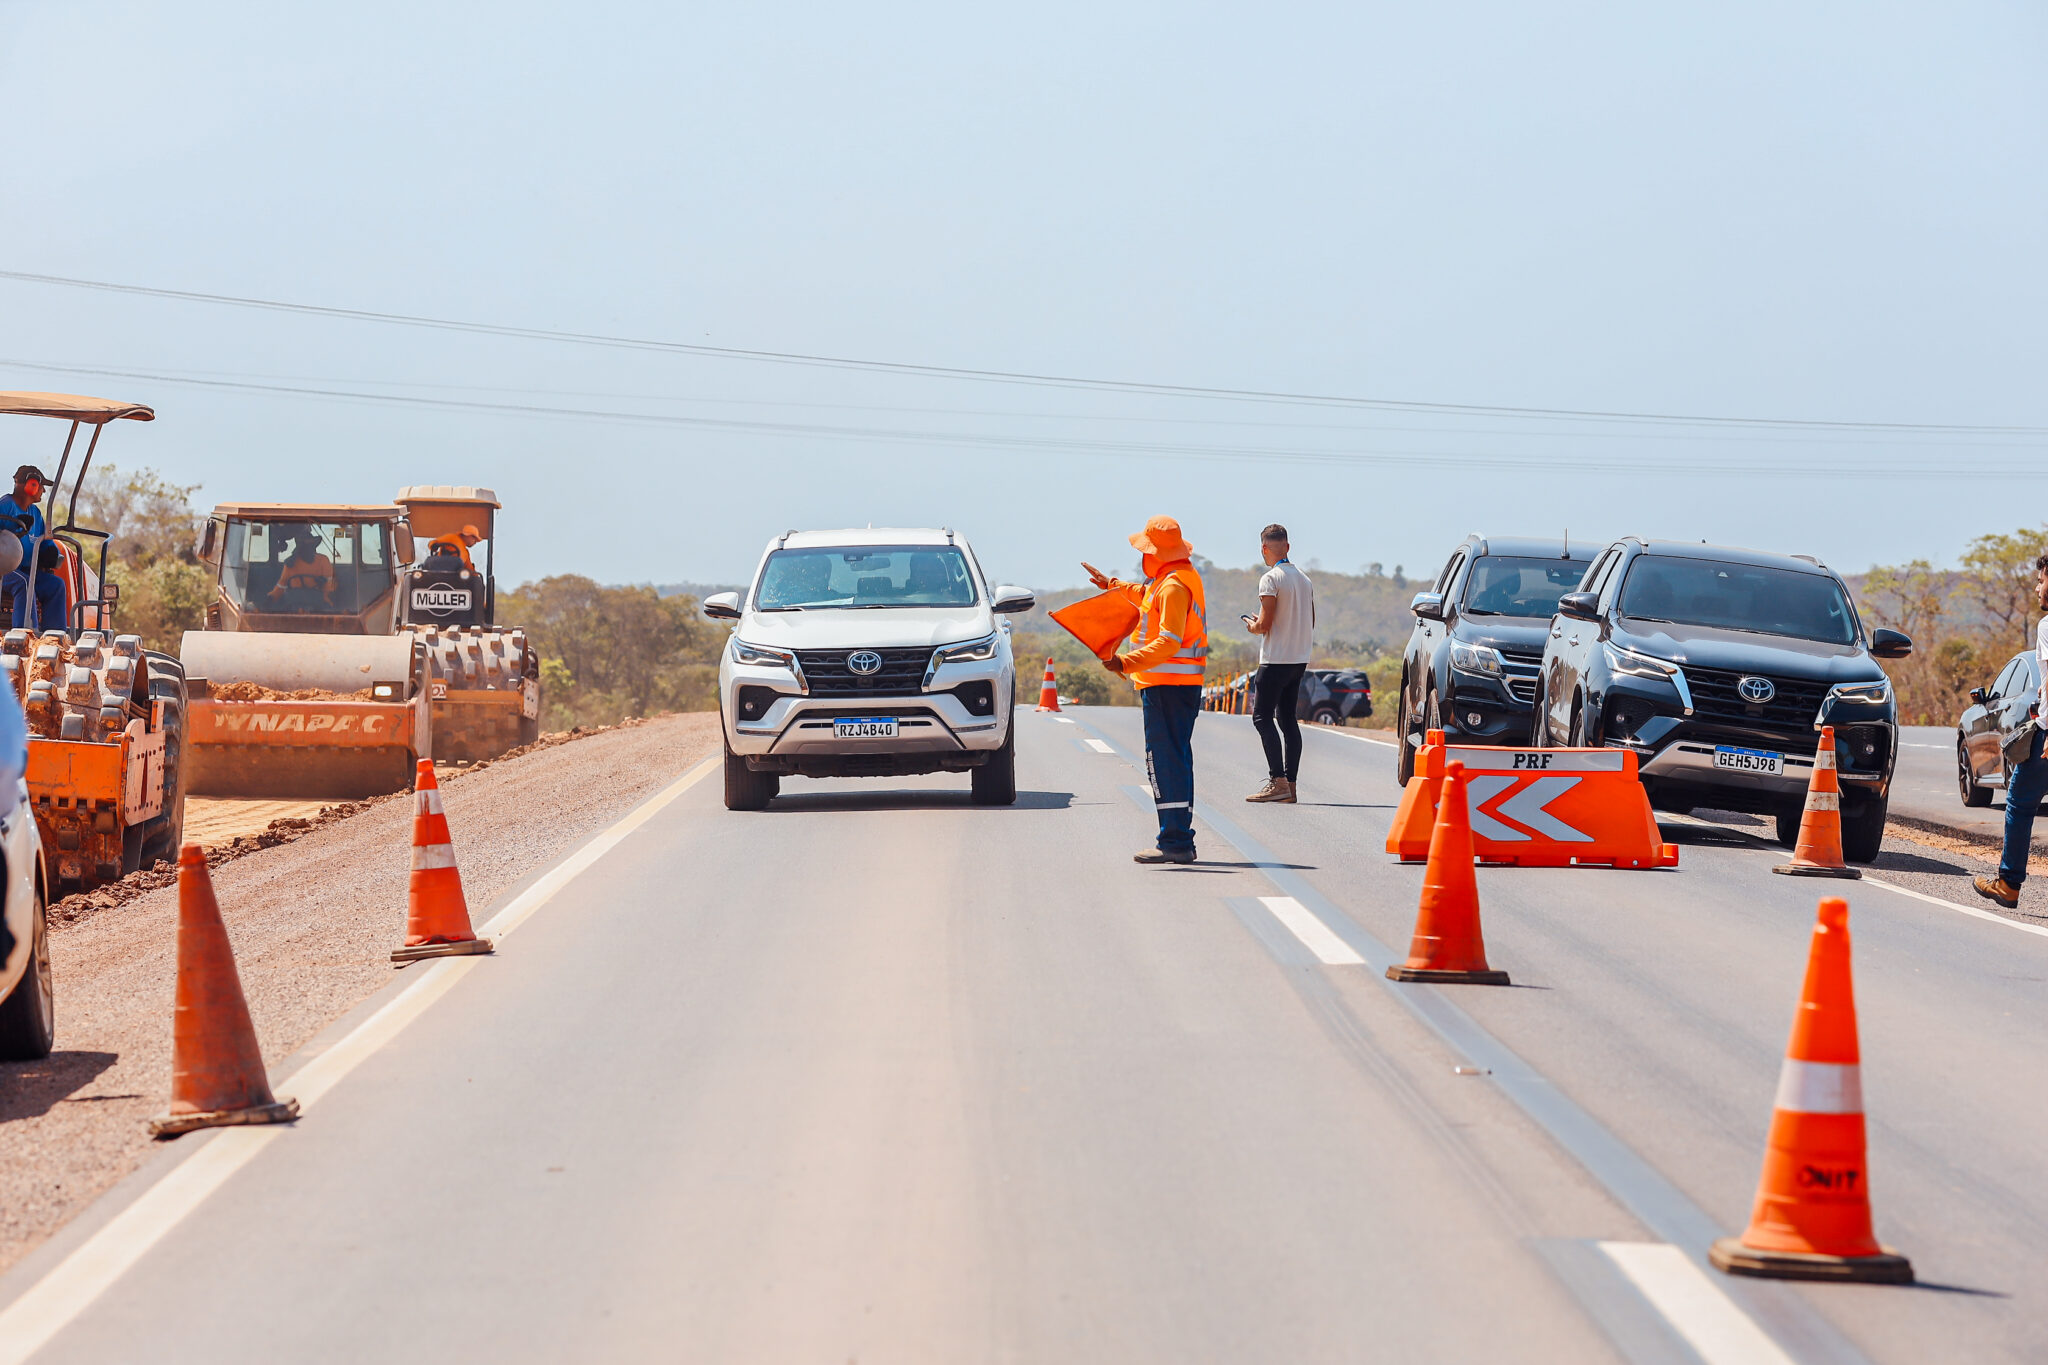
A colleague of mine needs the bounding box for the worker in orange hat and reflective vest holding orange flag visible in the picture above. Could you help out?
[1081,516,1208,864]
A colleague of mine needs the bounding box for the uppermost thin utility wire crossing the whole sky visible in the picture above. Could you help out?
[0,270,2048,436]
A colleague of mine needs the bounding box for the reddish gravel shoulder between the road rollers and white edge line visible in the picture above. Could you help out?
[0,712,719,1269]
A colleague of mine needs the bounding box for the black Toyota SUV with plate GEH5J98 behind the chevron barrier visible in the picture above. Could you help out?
[1530,538,1913,862]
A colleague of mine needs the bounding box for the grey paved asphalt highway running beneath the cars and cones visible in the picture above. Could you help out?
[0,708,2048,1365]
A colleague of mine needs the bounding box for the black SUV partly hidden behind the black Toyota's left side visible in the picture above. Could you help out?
[1395,536,1599,782]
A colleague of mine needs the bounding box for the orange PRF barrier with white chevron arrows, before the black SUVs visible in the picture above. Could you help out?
[1386,731,1677,868]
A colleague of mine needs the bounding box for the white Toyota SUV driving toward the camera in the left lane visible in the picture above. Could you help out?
[705,528,1032,810]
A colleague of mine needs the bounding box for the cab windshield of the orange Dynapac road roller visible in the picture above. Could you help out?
[221,522,393,616]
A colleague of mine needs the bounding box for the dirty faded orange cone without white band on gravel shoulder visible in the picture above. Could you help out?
[150,843,299,1138]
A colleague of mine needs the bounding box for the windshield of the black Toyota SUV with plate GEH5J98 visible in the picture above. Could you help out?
[1622,555,1855,645]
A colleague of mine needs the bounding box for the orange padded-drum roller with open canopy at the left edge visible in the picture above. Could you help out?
[0,393,188,896]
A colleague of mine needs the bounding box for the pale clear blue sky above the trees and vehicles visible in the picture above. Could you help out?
[0,0,2048,585]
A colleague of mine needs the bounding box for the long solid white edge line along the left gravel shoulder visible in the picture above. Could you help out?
[0,759,717,1365]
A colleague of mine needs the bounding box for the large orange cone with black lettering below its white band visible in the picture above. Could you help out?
[1708,896,1913,1285]
